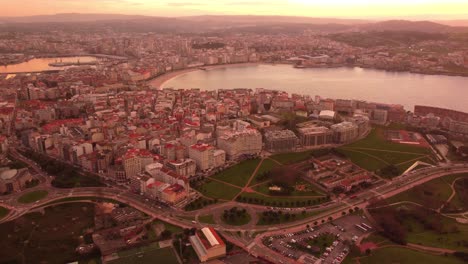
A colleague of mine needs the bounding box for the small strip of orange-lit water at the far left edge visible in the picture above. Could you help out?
[0,56,96,73]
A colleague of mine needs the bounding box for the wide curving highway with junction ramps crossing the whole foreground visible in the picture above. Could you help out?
[0,147,468,263]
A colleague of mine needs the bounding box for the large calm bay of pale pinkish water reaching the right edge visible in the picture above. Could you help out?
[163,65,468,112]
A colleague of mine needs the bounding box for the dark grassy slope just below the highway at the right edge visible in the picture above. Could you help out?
[387,174,468,209]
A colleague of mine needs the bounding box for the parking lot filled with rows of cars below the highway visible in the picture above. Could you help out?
[263,215,373,264]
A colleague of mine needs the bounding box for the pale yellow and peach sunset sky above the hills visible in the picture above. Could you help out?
[0,0,468,19]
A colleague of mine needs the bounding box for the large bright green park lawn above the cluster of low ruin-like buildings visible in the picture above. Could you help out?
[338,127,432,176]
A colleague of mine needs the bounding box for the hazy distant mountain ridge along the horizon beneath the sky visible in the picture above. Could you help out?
[0,13,468,33]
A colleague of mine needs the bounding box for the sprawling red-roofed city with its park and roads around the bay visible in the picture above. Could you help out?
[0,28,468,263]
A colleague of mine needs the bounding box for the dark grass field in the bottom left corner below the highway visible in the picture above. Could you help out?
[0,203,94,263]
